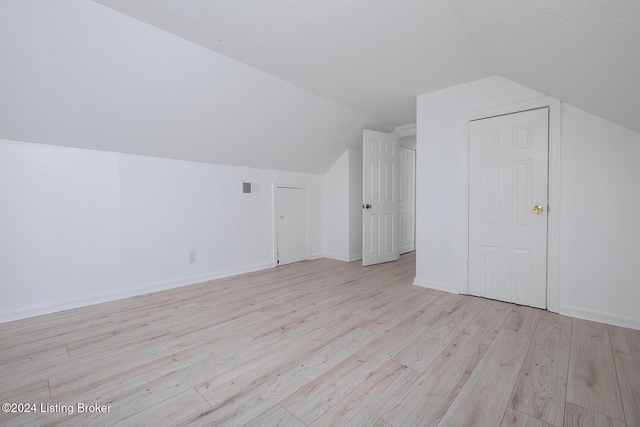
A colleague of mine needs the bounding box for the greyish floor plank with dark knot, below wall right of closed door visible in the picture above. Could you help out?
[567,319,624,421]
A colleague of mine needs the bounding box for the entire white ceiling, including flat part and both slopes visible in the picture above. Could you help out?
[0,0,640,173]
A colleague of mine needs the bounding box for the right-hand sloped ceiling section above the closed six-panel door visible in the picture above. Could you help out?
[450,0,640,132]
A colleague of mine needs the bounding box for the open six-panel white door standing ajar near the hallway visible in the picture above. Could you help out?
[362,129,400,265]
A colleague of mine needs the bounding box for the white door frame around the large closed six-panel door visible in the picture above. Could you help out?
[460,97,562,313]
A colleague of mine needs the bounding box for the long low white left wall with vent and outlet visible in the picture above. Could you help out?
[0,140,324,321]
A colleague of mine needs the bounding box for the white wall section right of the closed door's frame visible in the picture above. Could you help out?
[560,104,640,329]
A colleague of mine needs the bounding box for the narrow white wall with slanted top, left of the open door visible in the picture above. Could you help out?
[324,150,349,261]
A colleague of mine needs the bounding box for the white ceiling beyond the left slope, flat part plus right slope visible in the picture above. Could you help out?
[95,0,640,132]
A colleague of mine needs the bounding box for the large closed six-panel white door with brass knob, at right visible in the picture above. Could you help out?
[469,108,549,308]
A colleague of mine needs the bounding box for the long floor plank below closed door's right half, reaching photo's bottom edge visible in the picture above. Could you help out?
[440,330,531,426]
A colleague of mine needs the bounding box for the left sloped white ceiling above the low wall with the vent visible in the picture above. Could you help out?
[0,0,393,174]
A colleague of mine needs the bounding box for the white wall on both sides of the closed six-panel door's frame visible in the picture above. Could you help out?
[414,77,640,328]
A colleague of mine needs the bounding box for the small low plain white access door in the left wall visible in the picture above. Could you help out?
[276,187,307,265]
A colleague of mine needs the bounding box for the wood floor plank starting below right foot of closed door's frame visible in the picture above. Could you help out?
[509,320,571,426]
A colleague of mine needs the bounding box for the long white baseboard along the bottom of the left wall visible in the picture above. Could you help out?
[0,263,273,323]
